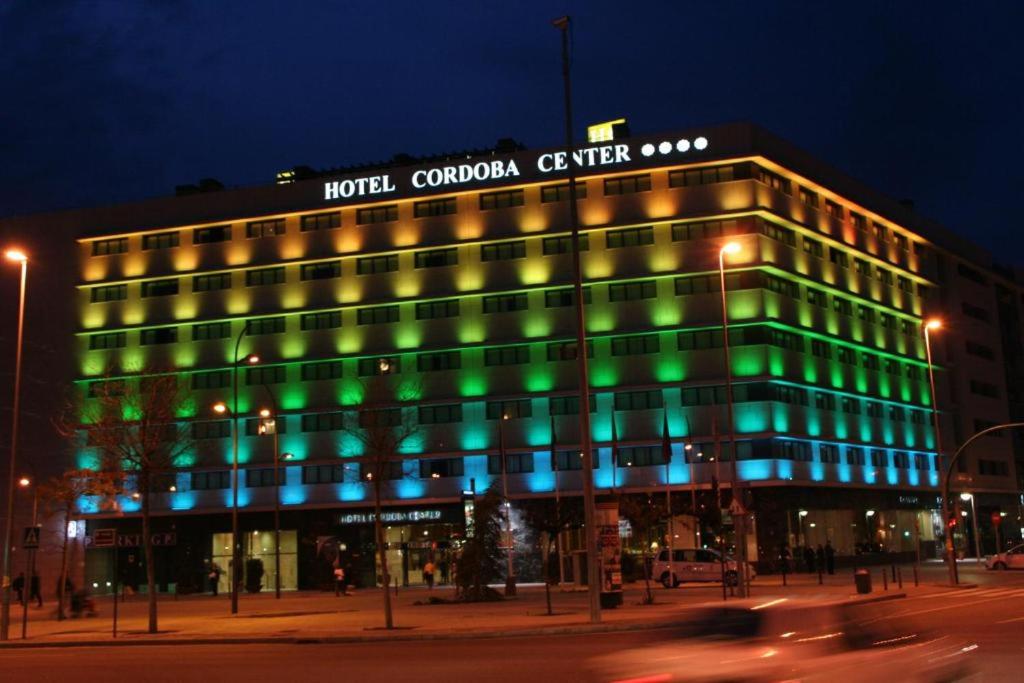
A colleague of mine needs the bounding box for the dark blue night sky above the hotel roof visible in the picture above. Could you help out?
[0,0,1024,262]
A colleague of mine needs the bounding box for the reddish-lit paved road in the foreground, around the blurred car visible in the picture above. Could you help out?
[0,573,1024,683]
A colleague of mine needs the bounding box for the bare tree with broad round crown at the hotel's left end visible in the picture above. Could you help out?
[61,369,194,633]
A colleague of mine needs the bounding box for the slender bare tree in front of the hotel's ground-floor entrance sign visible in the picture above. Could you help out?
[344,374,420,629]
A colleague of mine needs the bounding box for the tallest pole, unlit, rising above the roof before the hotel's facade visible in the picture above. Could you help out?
[552,14,601,624]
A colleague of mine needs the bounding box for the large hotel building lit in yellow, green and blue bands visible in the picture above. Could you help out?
[4,125,1024,588]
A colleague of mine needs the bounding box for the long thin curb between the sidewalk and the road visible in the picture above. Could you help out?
[0,593,906,652]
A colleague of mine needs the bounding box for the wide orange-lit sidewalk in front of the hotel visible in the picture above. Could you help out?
[0,570,944,647]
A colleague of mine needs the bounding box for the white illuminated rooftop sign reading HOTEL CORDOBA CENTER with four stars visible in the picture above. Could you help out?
[324,136,708,202]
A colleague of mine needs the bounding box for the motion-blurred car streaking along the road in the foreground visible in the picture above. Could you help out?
[588,598,978,683]
